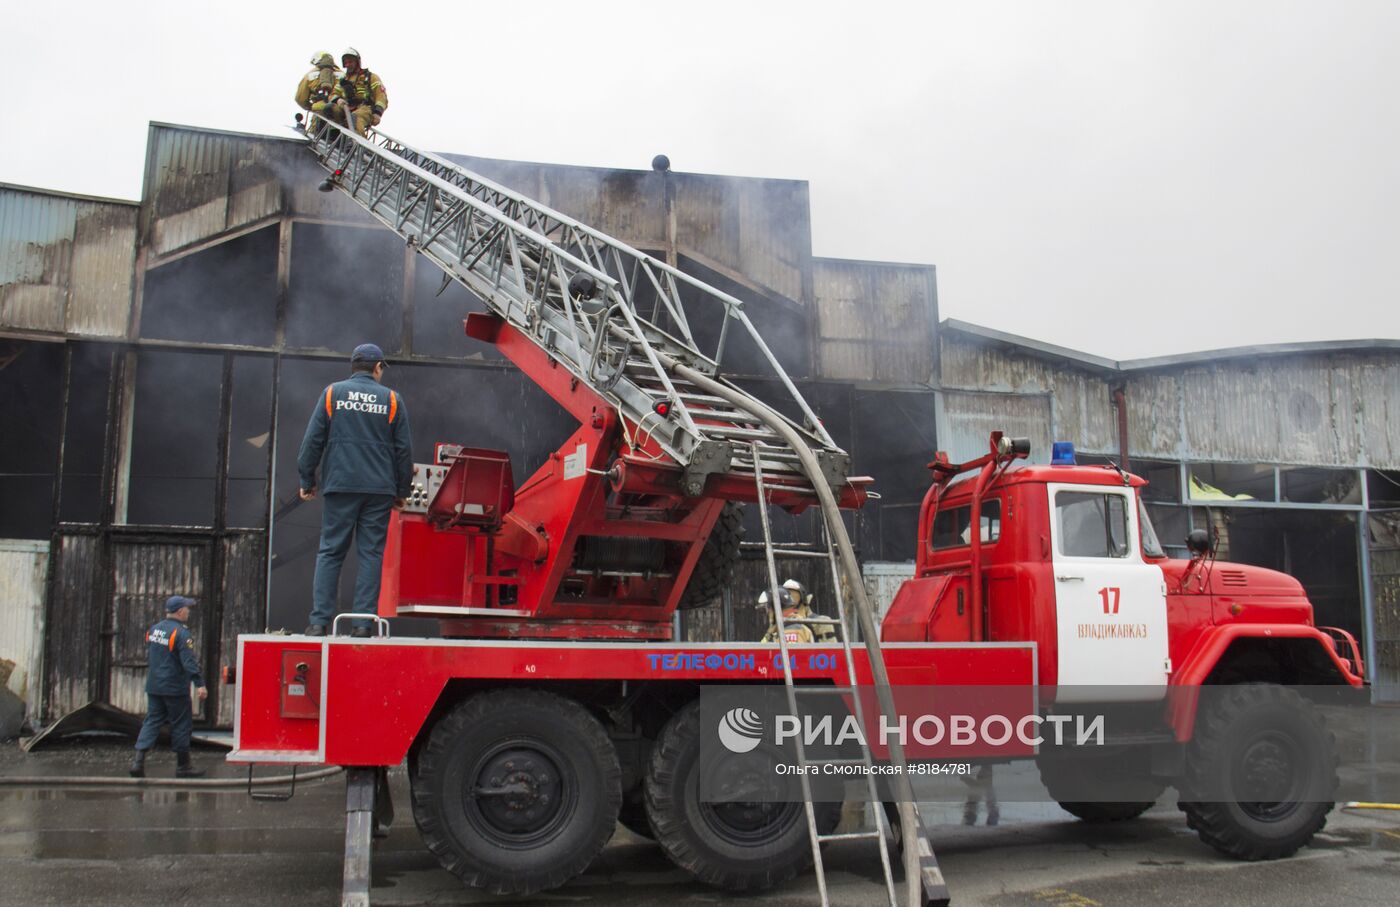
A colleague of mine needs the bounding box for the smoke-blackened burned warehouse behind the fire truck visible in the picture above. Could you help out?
[0,123,1400,726]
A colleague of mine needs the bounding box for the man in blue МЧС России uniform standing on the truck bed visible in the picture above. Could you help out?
[297,343,413,637]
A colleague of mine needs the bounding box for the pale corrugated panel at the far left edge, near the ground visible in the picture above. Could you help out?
[0,539,49,715]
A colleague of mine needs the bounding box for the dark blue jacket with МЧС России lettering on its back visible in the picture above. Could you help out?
[297,372,413,497]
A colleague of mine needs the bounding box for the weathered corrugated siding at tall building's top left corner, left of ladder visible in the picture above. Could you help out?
[143,126,292,256]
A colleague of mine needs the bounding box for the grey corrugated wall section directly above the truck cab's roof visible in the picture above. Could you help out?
[939,335,1114,453]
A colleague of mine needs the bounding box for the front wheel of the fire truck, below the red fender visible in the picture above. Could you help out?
[1179,683,1337,859]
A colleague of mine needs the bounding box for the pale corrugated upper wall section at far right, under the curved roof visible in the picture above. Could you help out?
[1127,353,1400,469]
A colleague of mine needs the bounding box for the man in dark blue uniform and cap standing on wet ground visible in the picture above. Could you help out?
[132,595,209,778]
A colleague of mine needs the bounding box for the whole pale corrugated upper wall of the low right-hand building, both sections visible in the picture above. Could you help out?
[939,321,1400,469]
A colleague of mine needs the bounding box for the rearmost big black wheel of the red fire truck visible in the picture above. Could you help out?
[413,690,622,894]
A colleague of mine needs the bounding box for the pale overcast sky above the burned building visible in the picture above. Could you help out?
[0,0,1400,358]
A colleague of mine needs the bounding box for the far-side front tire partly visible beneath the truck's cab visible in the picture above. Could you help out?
[1037,750,1166,822]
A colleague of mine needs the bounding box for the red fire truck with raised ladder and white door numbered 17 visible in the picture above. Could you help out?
[230,116,1364,893]
